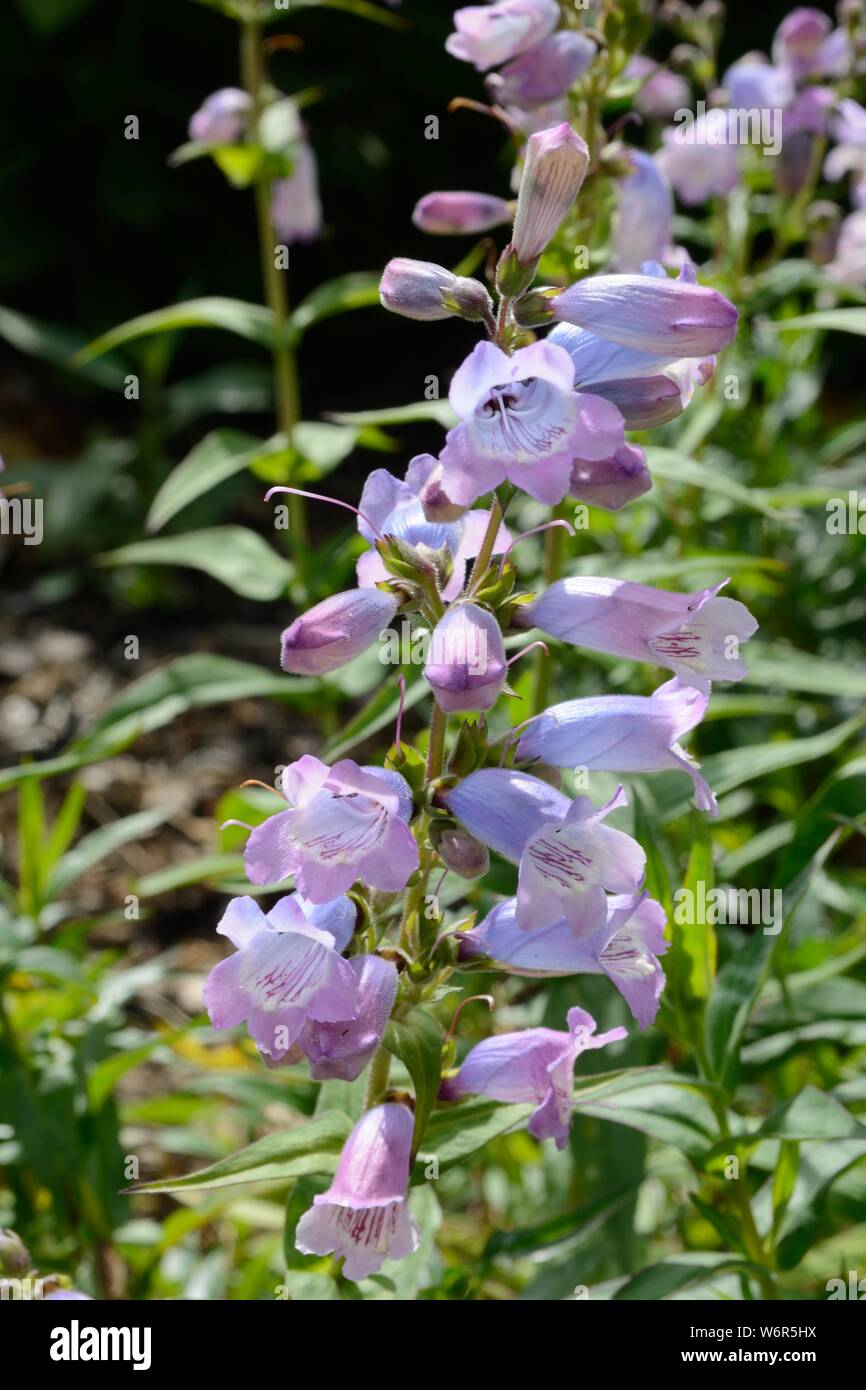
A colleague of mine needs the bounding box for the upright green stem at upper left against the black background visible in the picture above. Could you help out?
[240,15,307,543]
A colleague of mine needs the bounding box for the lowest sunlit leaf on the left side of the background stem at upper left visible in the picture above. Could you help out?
[100,525,295,602]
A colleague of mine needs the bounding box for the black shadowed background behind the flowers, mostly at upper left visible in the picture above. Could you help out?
[0,0,830,459]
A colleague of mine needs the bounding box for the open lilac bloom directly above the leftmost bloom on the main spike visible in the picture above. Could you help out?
[243,753,418,904]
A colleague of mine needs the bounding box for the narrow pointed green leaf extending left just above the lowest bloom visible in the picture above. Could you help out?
[128,1111,352,1193]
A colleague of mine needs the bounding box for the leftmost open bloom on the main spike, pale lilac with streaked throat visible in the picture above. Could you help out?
[204,894,359,1061]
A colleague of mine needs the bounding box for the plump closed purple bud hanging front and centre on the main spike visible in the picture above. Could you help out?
[424,603,507,714]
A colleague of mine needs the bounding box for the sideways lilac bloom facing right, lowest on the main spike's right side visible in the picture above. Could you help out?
[439,1009,626,1148]
